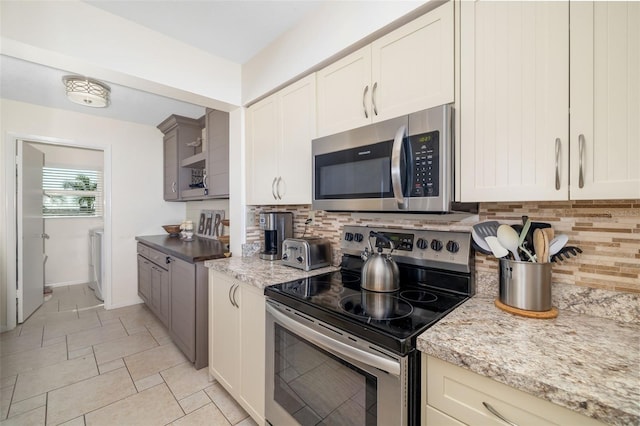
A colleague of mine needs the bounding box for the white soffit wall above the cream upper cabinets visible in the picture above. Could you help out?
[242,0,432,105]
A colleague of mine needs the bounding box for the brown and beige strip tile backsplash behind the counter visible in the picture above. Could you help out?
[247,200,640,293]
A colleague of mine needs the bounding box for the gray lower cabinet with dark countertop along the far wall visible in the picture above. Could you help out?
[138,243,209,369]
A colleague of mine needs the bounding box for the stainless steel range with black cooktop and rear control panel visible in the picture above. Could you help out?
[265,226,475,425]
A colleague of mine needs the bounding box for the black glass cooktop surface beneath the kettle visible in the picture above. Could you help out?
[265,270,468,355]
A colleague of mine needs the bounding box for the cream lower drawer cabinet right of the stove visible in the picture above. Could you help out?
[422,354,602,426]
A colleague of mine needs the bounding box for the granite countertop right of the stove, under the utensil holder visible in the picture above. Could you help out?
[418,296,640,425]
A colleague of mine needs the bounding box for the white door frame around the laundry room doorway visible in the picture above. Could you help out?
[4,132,112,330]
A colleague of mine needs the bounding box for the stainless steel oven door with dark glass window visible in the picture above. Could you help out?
[265,300,408,425]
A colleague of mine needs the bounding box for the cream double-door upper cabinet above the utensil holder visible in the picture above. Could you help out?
[459,1,640,202]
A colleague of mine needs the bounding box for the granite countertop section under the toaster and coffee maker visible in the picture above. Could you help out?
[204,256,339,289]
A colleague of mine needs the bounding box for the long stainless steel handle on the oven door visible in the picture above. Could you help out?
[266,303,400,377]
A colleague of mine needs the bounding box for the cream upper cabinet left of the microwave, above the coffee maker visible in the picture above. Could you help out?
[246,74,316,205]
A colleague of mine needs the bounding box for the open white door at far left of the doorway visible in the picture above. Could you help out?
[16,141,46,323]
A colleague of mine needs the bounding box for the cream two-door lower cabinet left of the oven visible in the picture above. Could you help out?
[209,270,265,424]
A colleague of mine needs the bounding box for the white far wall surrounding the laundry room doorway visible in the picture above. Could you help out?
[0,99,185,328]
